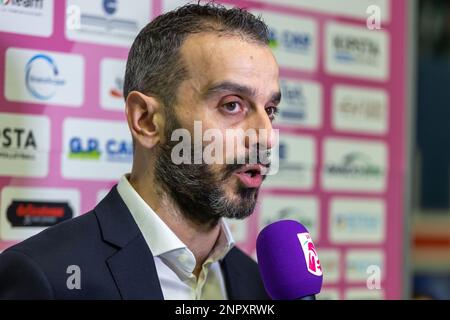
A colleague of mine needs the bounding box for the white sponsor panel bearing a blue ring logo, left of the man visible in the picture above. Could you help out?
[5,48,84,107]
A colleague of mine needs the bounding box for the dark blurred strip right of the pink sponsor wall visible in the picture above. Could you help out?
[411,0,450,299]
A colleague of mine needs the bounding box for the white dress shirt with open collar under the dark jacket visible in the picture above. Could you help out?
[117,175,234,300]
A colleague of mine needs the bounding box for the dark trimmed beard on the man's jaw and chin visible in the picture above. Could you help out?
[155,111,259,226]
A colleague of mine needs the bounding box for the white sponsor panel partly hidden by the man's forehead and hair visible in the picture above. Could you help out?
[251,10,319,72]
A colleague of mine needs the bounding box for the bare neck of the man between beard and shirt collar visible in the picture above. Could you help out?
[129,174,220,277]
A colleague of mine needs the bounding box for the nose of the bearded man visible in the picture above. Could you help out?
[245,109,274,150]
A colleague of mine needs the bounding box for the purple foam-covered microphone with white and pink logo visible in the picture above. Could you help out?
[256,220,323,300]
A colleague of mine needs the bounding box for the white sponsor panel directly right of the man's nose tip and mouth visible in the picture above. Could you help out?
[263,134,316,190]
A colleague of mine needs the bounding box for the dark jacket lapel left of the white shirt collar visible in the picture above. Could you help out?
[95,186,164,300]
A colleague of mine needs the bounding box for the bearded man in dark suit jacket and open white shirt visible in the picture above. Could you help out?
[0,4,280,299]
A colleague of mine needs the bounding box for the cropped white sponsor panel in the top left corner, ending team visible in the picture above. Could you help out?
[0,0,54,37]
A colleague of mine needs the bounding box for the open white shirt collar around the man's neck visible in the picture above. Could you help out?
[117,175,235,274]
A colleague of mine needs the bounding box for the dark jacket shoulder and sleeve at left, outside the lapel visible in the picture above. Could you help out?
[0,211,118,299]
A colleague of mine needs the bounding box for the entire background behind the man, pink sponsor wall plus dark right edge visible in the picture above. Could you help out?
[0,0,450,299]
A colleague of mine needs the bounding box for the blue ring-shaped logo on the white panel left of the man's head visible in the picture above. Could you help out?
[25,54,66,100]
